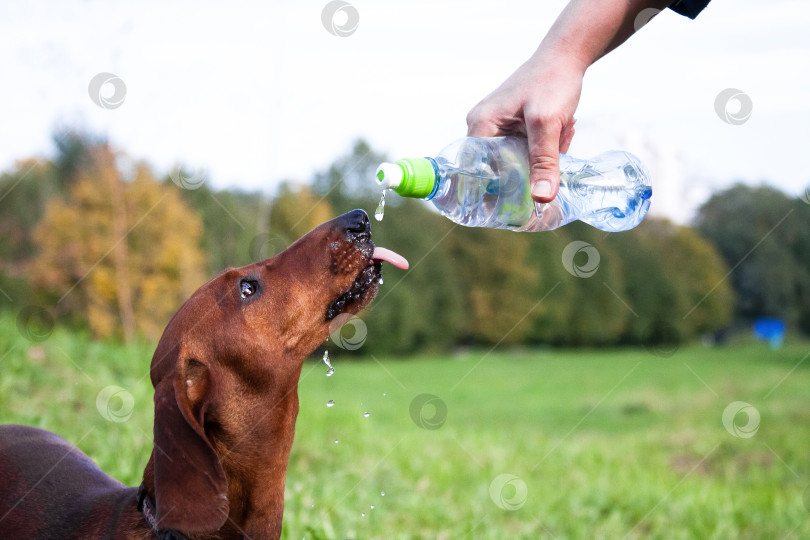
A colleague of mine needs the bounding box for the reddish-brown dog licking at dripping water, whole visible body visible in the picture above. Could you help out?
[0,210,407,540]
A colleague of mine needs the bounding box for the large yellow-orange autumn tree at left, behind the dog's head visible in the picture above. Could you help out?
[31,144,205,339]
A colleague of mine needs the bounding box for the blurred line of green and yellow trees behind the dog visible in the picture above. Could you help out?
[0,132,810,354]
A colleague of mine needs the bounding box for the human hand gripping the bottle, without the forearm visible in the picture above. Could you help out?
[467,51,587,203]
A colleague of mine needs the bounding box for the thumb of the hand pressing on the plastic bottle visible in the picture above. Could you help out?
[527,121,560,203]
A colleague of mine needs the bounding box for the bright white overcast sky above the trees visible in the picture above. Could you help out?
[0,0,810,221]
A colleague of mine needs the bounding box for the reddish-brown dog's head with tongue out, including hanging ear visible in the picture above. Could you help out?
[144,210,407,532]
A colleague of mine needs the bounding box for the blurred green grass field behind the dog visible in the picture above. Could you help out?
[0,317,810,539]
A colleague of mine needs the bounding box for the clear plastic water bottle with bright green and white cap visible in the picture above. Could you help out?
[376,137,652,231]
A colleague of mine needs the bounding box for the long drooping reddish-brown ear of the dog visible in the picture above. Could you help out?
[154,360,229,533]
